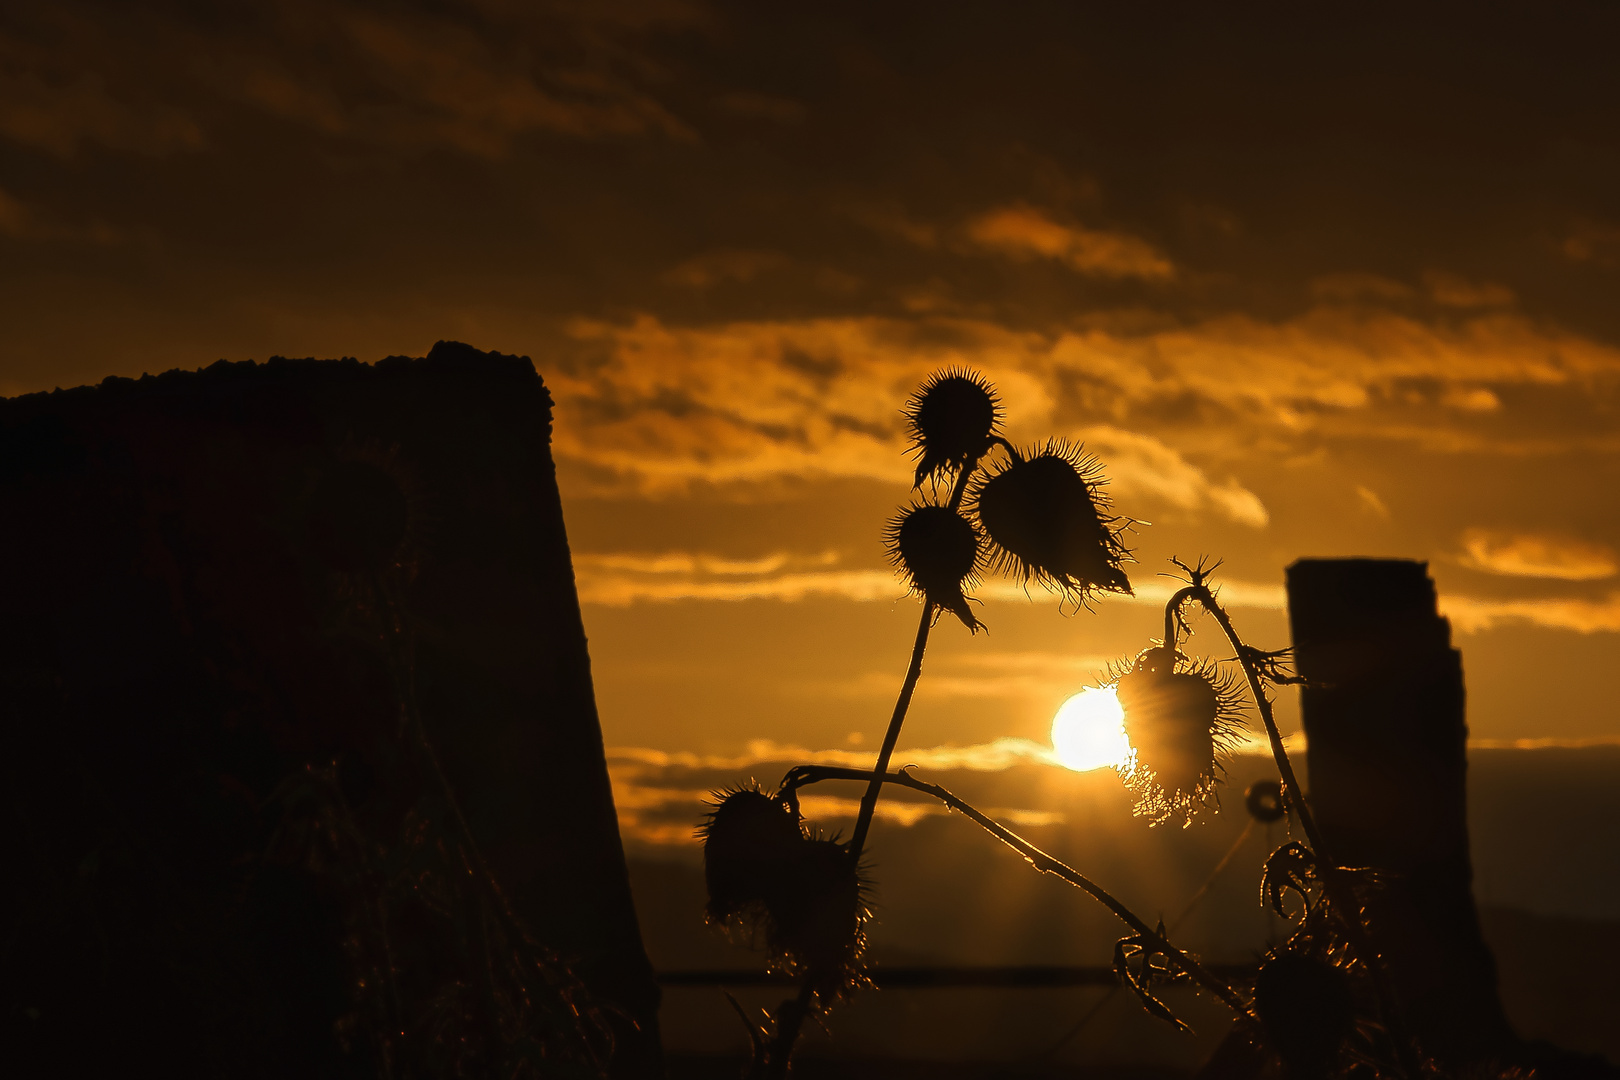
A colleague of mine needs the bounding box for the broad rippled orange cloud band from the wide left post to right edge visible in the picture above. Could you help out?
[546,306,1620,514]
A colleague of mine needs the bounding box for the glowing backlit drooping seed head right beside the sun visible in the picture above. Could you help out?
[1115,646,1243,824]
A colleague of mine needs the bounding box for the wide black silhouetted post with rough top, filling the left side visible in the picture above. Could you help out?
[0,342,663,1078]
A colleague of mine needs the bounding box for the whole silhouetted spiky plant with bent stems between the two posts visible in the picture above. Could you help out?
[700,371,1422,1080]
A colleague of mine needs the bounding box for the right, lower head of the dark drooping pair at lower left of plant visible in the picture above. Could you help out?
[768,839,867,996]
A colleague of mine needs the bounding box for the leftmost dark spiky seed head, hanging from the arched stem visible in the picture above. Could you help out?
[698,784,805,926]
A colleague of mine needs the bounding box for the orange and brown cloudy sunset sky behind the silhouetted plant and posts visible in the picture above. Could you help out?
[0,0,1620,854]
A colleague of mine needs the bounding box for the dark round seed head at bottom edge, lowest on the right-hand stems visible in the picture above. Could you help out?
[1254,952,1356,1080]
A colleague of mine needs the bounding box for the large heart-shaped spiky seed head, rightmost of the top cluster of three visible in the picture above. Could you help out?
[974,439,1131,604]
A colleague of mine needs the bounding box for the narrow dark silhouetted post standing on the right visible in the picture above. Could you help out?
[1288,559,1513,1065]
